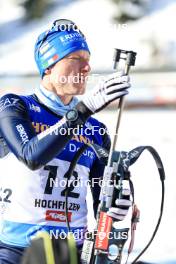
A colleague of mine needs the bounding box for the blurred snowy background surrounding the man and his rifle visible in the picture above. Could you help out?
[0,0,176,264]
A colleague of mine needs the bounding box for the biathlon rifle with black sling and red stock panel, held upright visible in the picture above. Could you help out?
[81,49,165,264]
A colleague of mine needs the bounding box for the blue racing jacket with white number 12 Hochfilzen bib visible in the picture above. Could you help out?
[0,94,110,247]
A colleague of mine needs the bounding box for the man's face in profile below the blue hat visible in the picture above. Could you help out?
[49,50,91,96]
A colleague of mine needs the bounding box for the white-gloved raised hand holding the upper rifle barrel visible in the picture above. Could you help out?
[82,72,131,113]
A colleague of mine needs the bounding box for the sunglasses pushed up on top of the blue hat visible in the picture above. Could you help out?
[38,19,85,49]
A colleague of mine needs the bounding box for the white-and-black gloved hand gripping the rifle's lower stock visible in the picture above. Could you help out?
[107,189,132,221]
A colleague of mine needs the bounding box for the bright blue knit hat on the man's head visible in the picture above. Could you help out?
[34,19,90,77]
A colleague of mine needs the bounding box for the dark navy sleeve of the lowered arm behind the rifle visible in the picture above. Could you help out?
[90,124,111,218]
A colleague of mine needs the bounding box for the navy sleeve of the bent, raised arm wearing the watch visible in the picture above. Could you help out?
[0,94,91,170]
